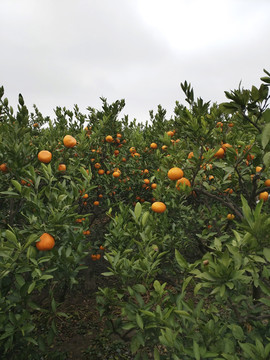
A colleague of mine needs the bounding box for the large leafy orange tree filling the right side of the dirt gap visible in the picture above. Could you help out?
[97,72,270,359]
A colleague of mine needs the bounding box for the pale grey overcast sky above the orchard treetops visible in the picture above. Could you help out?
[0,0,270,122]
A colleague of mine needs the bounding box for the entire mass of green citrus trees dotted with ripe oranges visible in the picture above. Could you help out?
[0,70,270,360]
